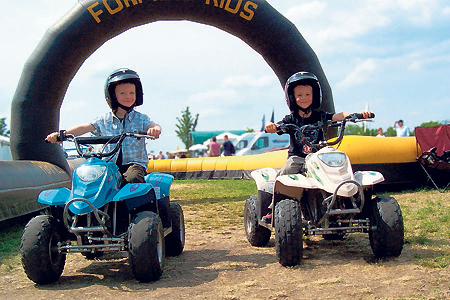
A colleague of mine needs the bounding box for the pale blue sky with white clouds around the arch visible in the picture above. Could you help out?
[0,0,450,152]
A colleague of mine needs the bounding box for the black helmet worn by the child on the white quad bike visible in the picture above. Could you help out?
[284,72,322,113]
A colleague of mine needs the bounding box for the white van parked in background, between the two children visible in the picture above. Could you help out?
[234,132,289,156]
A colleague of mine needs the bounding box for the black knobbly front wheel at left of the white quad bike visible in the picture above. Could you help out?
[275,199,303,267]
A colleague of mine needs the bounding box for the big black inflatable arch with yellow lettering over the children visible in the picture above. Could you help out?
[11,0,334,173]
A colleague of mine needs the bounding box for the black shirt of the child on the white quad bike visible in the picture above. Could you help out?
[278,110,334,157]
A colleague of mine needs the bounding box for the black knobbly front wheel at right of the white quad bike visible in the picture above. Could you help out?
[369,196,404,258]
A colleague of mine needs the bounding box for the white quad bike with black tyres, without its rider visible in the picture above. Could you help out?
[244,114,404,266]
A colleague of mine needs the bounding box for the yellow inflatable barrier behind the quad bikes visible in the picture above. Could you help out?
[148,136,421,183]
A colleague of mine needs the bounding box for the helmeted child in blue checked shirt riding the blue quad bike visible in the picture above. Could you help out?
[46,68,161,183]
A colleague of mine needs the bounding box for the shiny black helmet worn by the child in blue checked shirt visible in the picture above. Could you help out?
[105,68,144,111]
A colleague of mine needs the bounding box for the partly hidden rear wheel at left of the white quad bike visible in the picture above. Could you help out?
[244,195,271,247]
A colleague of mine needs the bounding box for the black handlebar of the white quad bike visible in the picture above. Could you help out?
[277,113,375,149]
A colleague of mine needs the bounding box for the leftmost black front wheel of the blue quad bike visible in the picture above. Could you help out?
[20,215,66,284]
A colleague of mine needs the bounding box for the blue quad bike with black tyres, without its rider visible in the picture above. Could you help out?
[20,132,185,284]
